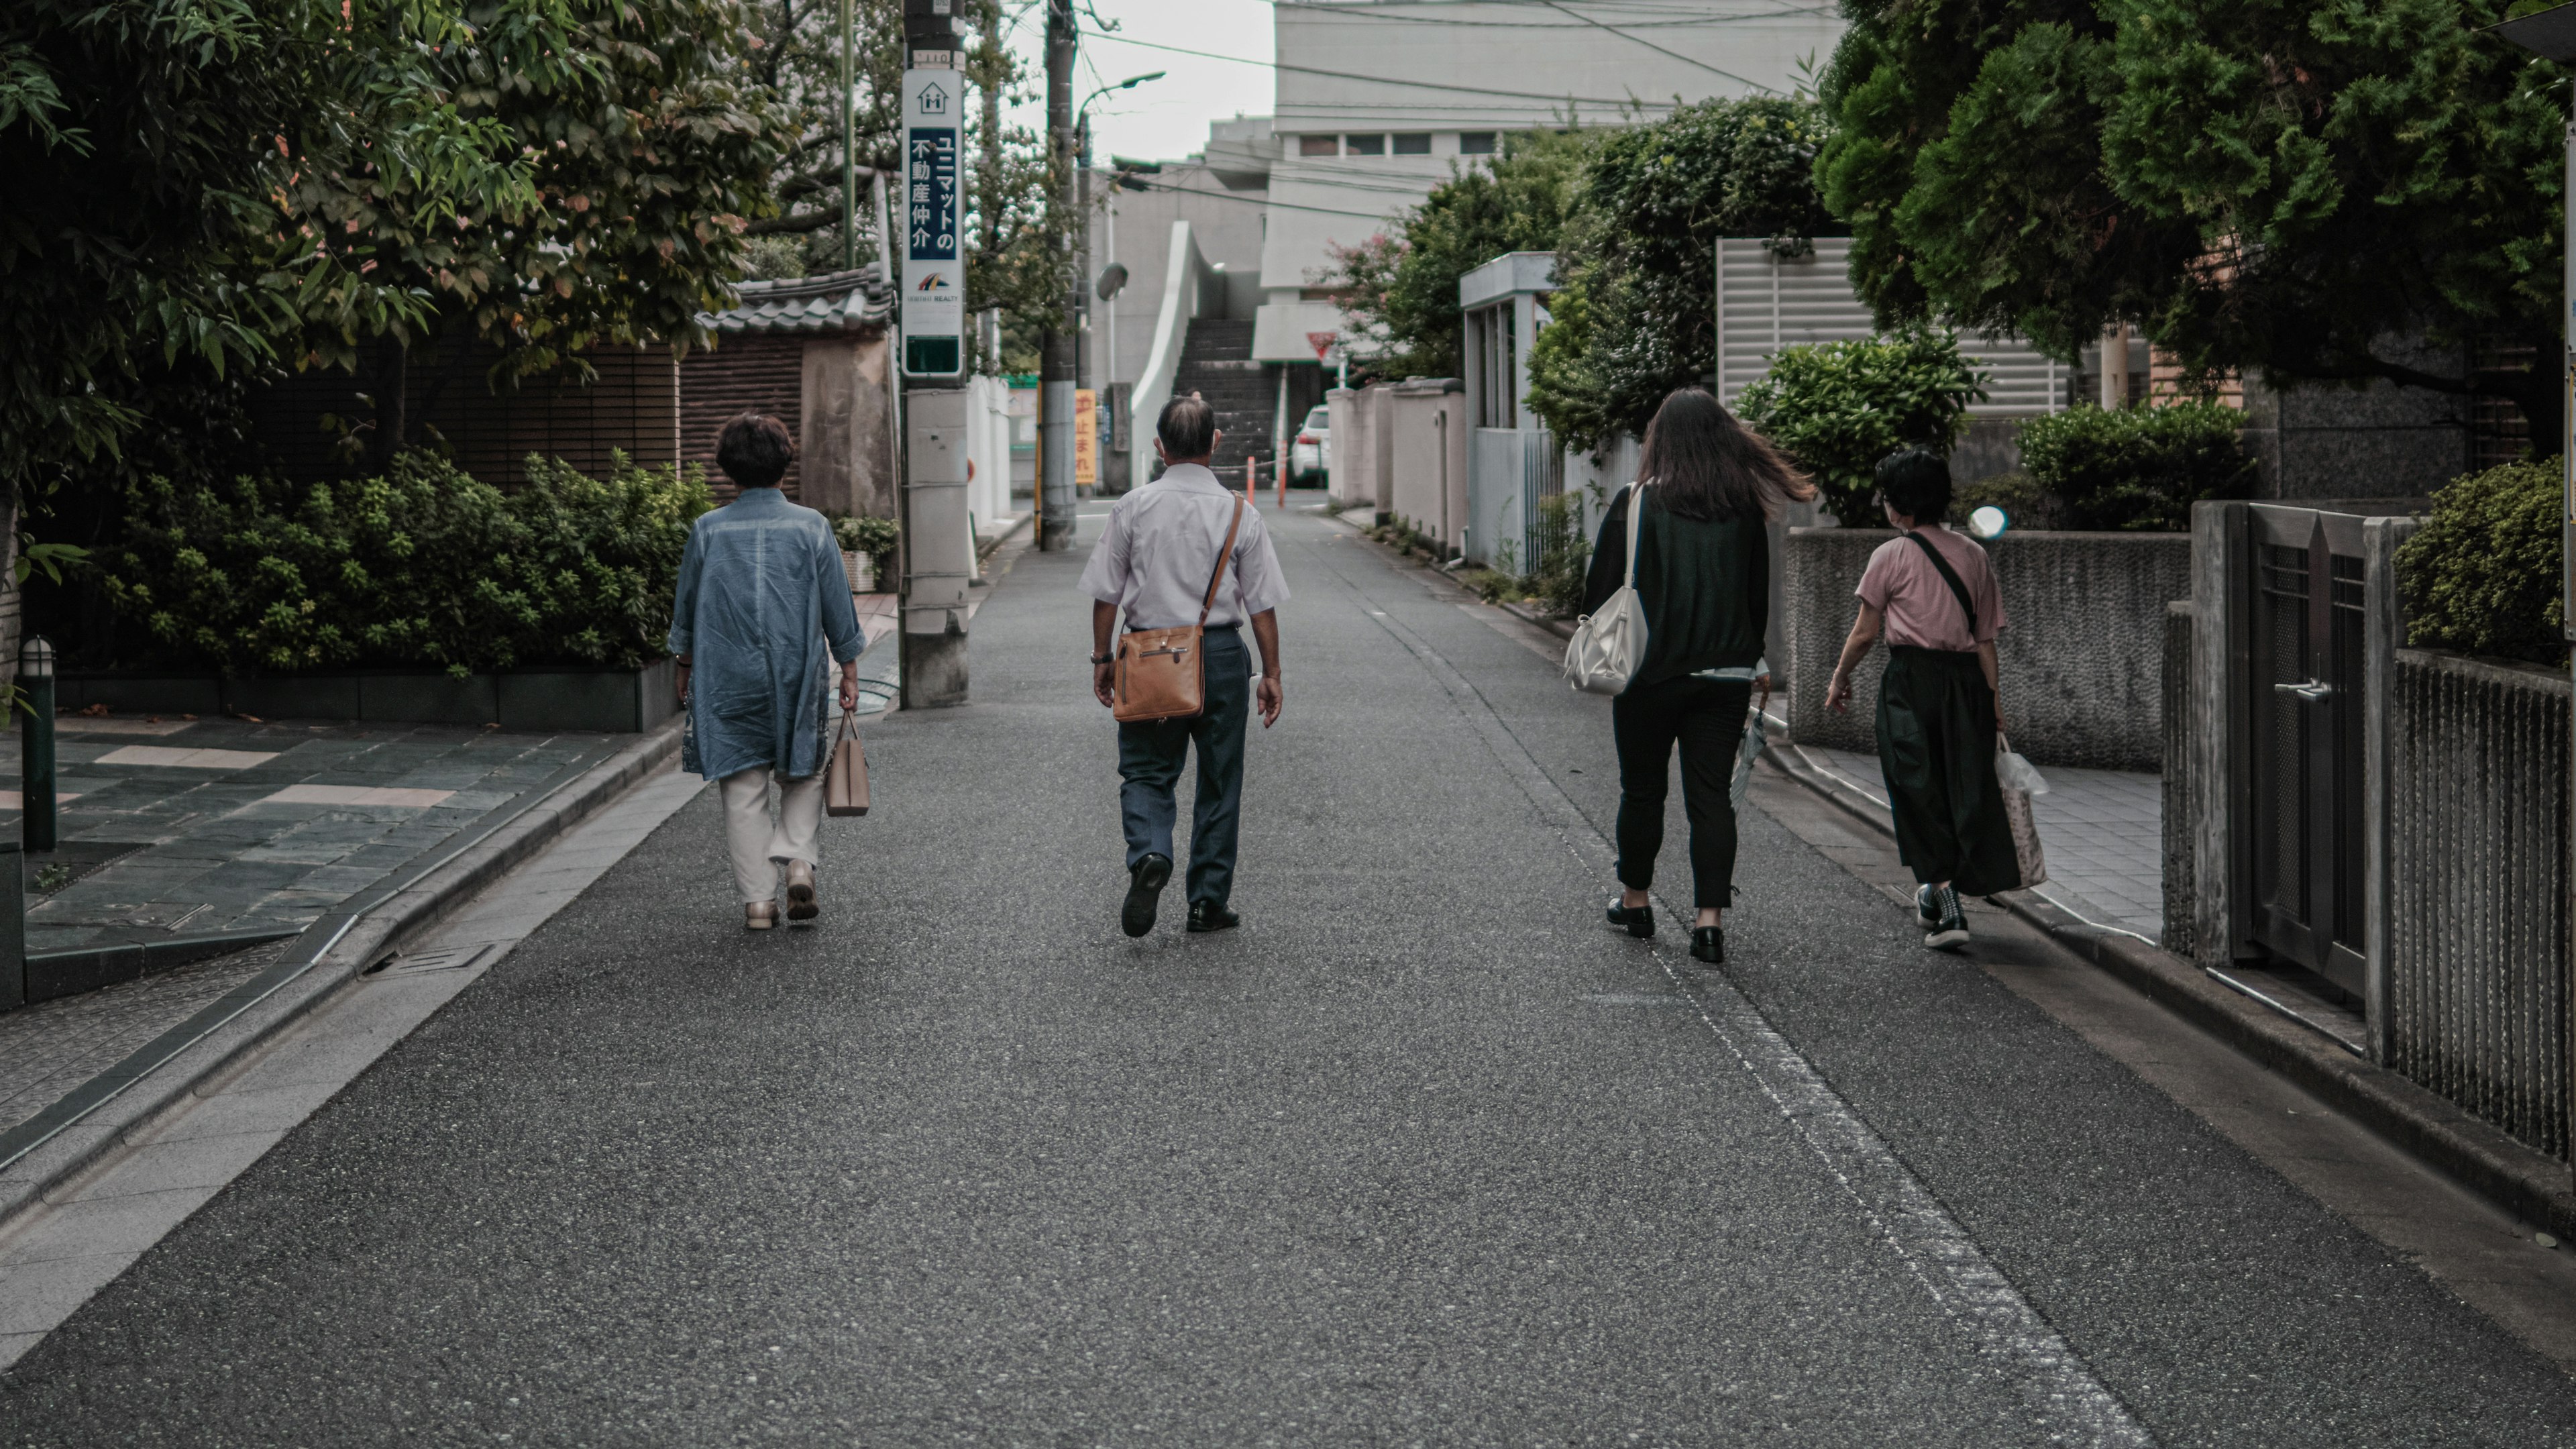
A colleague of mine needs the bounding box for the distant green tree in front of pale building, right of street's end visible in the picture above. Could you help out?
[1311,131,1600,379]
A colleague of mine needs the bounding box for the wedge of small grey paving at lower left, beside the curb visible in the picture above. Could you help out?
[0,941,286,1127]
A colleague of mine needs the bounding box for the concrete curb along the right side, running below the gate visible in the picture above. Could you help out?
[1762,748,2576,1240]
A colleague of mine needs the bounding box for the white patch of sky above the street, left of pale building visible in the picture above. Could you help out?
[1005,0,1278,162]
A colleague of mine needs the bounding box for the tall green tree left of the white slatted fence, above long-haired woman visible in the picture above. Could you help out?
[1530,98,1834,446]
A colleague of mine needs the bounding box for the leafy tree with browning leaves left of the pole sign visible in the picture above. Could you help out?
[278,0,788,456]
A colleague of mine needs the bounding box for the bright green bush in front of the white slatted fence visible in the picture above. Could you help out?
[1736,327,1986,529]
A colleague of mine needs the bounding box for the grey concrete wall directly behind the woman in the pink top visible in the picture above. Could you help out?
[1780,529,2192,771]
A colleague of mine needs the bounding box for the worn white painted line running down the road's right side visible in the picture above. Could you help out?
[1324,533,2156,1449]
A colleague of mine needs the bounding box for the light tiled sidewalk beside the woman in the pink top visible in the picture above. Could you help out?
[1780,743,2164,941]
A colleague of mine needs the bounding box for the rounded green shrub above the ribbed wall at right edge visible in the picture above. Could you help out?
[2398,459,2568,665]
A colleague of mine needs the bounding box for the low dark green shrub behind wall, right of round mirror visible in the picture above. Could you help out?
[2022,402,2257,531]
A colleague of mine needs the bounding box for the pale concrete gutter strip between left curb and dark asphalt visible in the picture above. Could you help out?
[0,771,706,1369]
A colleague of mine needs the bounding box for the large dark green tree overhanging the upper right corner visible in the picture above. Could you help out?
[1819,0,2566,436]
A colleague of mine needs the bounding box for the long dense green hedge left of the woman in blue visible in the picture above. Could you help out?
[103,453,714,676]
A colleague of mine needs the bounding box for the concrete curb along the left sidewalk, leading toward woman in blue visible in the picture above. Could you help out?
[0,716,685,1232]
